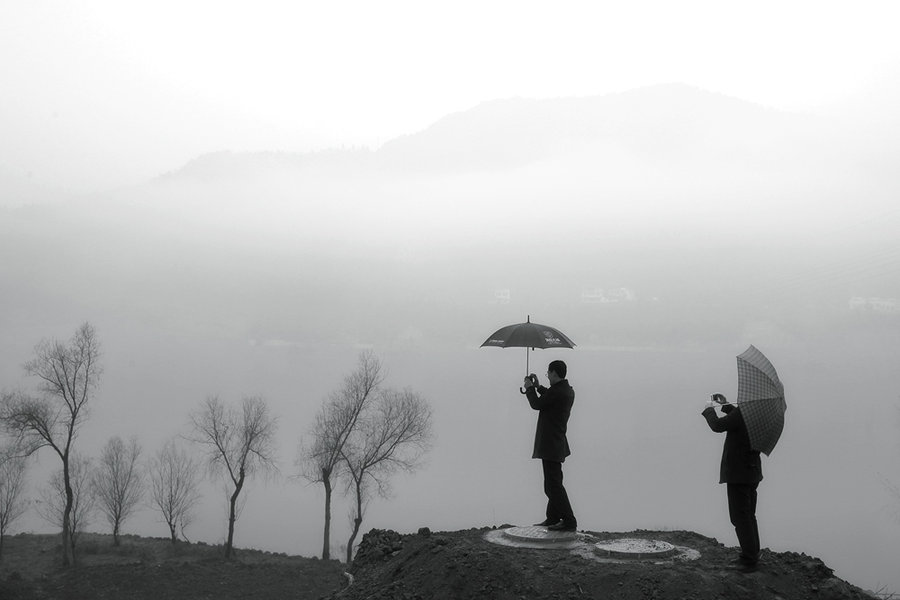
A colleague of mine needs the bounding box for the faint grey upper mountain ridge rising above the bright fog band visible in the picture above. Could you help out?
[155,84,844,179]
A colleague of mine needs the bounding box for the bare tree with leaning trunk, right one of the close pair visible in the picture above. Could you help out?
[341,390,432,563]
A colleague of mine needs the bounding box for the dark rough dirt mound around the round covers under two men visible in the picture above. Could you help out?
[331,528,873,600]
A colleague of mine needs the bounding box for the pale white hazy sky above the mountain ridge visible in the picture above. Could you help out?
[0,0,900,191]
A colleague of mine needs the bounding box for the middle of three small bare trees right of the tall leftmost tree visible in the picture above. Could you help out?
[91,436,144,546]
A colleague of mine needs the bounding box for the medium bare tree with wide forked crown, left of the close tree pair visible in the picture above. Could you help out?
[191,397,276,557]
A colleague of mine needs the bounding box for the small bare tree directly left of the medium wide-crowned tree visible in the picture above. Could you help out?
[150,440,200,544]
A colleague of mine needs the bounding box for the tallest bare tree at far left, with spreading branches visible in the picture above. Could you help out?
[0,323,102,566]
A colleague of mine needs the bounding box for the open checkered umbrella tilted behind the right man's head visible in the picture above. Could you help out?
[737,346,787,456]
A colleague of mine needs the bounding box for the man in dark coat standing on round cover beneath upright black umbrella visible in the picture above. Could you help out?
[525,360,578,531]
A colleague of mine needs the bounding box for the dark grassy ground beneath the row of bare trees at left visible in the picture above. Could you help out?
[0,533,344,600]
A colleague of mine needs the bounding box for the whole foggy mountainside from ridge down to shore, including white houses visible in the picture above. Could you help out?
[0,85,900,344]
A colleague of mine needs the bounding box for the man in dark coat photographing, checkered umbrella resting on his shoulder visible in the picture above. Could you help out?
[701,394,762,571]
